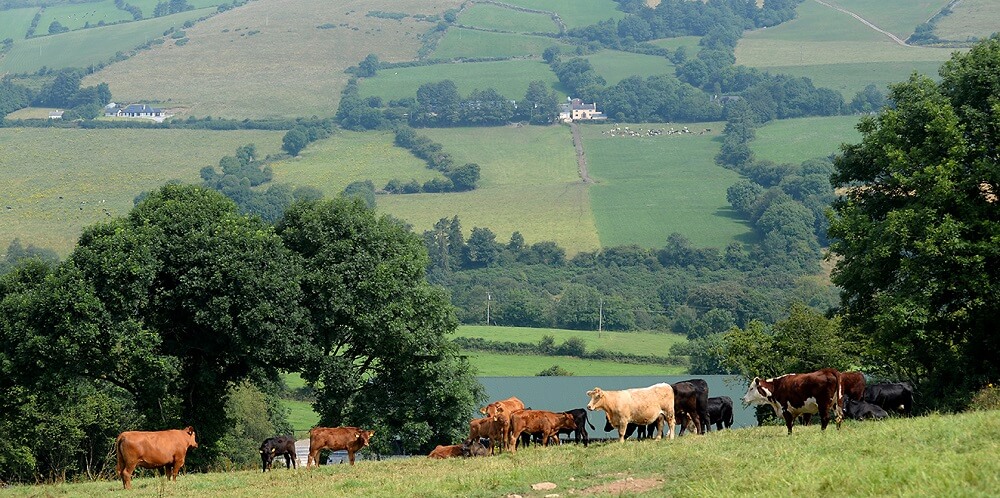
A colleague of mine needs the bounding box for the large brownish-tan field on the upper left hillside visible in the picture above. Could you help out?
[84,0,461,118]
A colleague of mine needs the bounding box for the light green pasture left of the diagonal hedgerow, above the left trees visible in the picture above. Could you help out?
[272,130,442,197]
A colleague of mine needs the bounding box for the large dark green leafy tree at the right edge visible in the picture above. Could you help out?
[830,36,1000,403]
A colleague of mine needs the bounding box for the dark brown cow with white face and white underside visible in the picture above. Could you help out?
[743,368,844,434]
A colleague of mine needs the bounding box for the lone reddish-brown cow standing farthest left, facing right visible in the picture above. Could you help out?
[115,426,198,489]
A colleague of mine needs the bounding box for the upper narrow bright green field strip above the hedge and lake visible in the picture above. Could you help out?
[454,325,687,357]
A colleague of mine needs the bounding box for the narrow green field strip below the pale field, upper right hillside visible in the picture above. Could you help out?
[760,61,942,99]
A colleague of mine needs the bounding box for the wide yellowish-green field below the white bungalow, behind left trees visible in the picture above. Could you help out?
[0,128,283,256]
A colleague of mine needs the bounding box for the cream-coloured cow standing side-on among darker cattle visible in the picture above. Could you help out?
[587,383,674,442]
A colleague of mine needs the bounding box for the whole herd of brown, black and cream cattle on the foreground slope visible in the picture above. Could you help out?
[115,368,913,489]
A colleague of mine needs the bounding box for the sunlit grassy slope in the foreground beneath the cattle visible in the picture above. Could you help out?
[2,412,1000,498]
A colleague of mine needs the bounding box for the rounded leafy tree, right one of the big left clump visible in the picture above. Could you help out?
[278,198,483,449]
